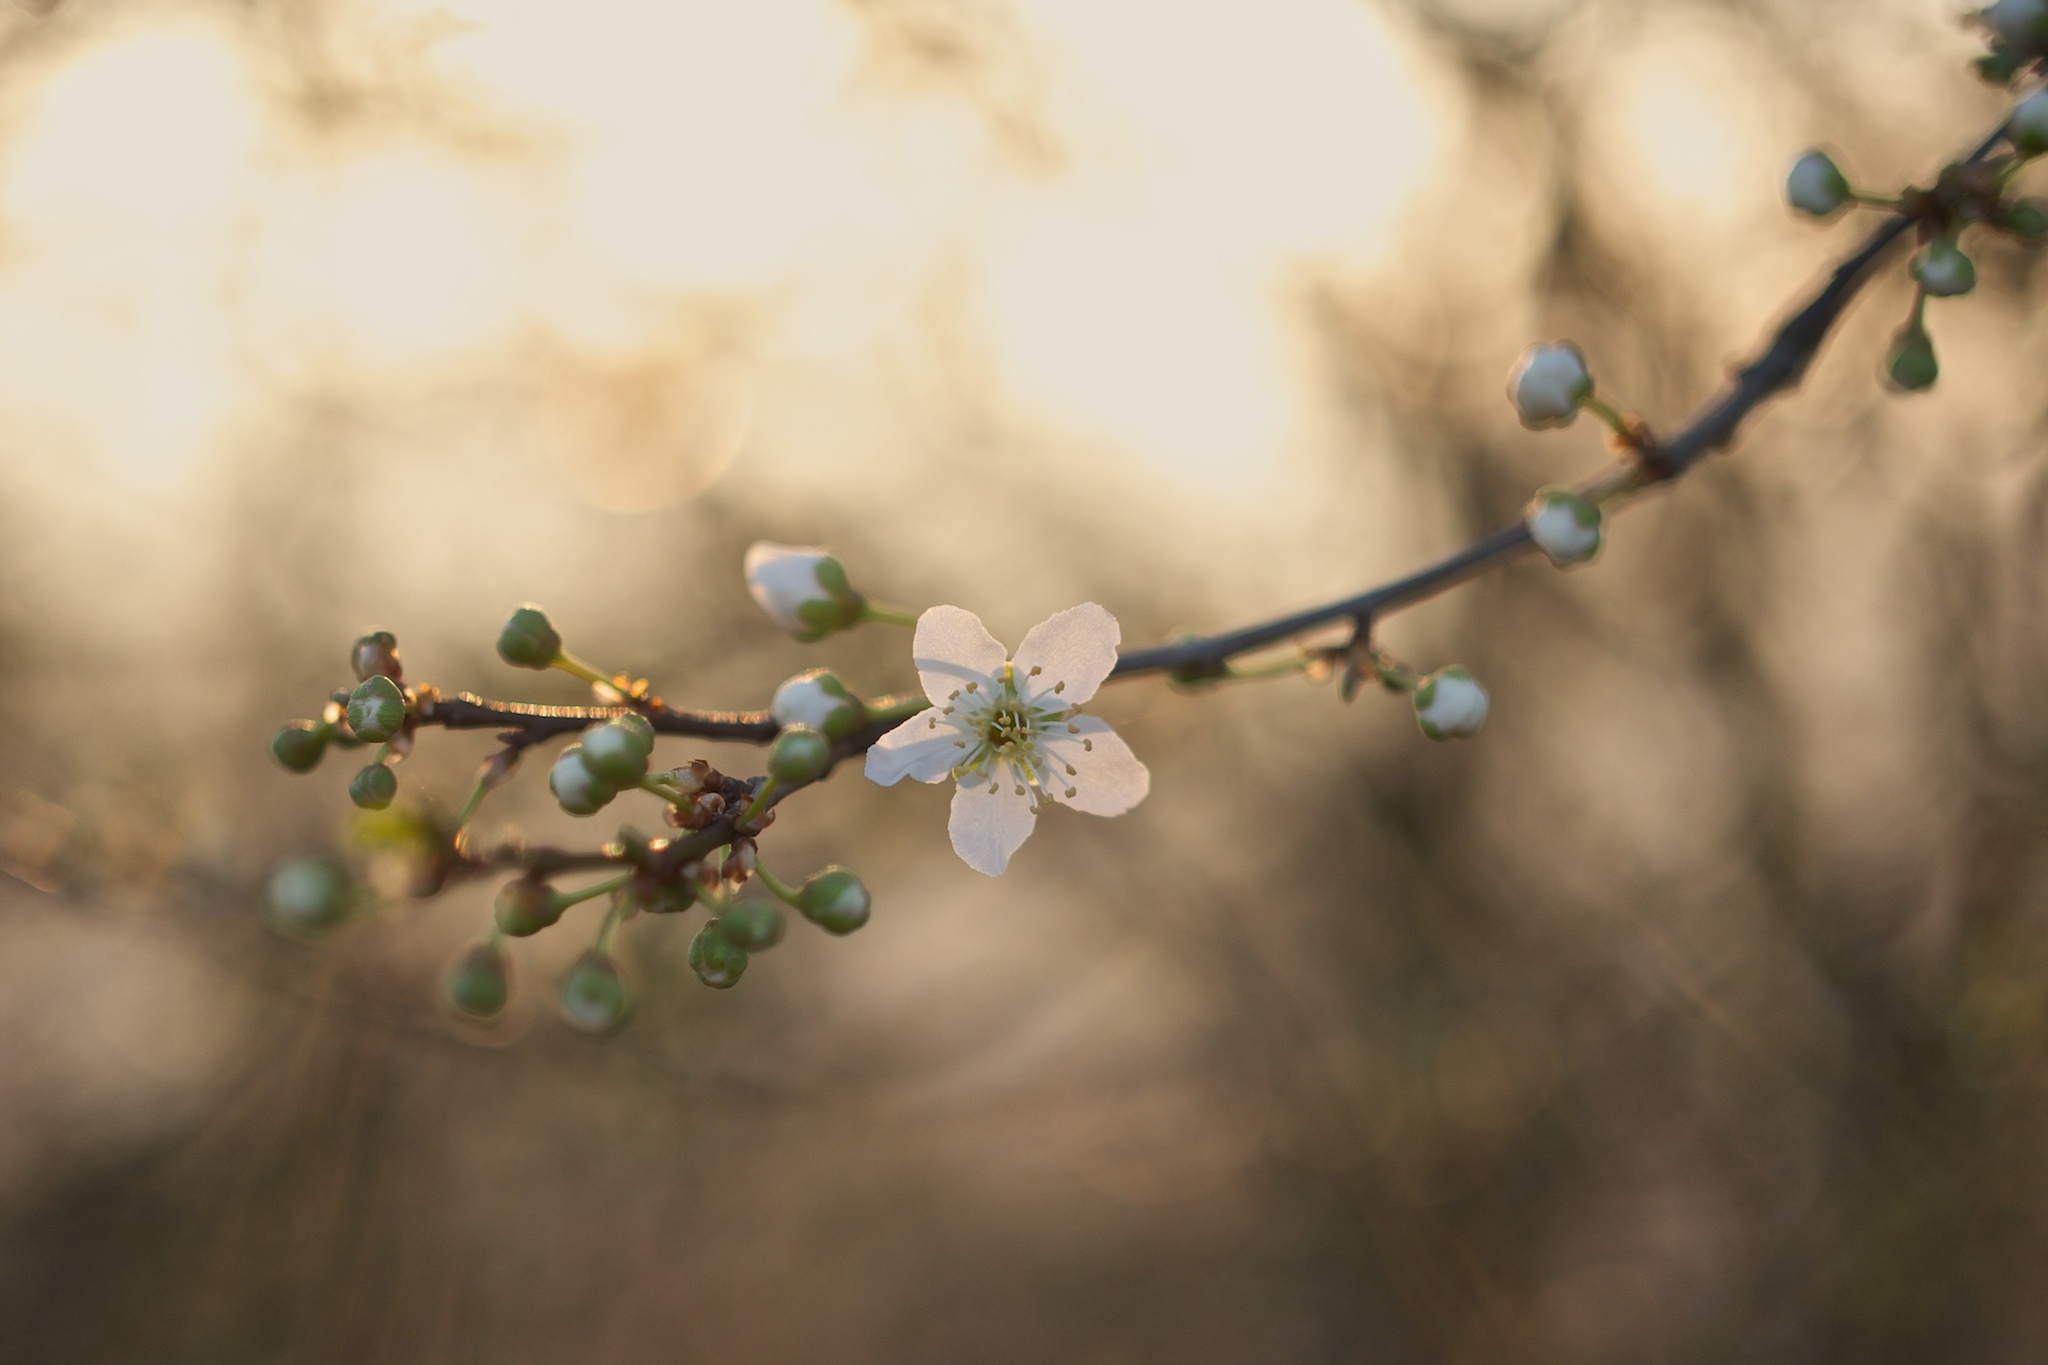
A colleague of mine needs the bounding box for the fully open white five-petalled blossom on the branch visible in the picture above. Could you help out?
[866,602,1151,876]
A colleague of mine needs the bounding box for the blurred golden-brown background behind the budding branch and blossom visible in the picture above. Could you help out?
[0,0,2048,1365]
